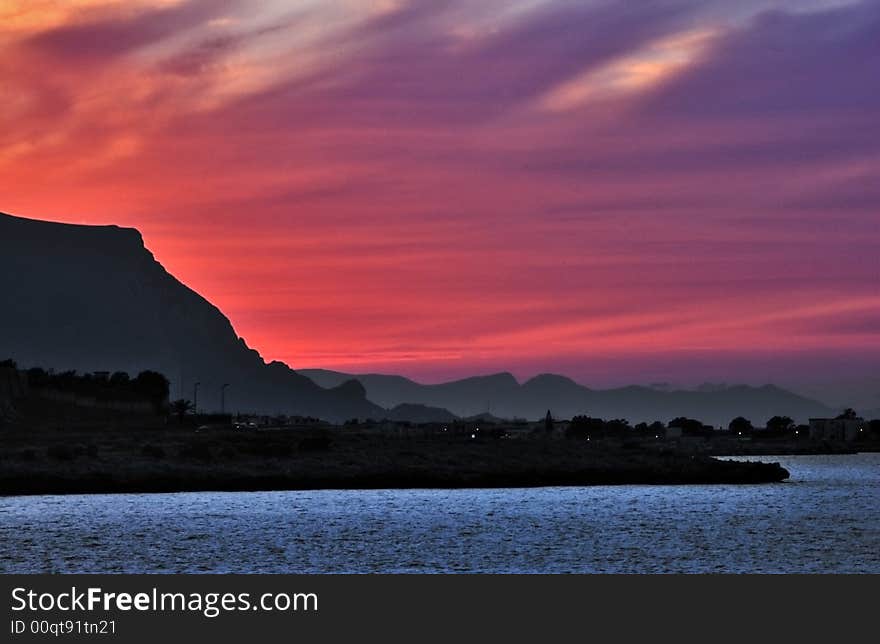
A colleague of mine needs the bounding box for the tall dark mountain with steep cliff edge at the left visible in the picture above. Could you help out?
[0,213,385,421]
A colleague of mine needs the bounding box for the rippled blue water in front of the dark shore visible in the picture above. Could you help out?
[0,454,880,573]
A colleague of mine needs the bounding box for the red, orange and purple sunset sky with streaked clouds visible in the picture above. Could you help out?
[0,0,880,392]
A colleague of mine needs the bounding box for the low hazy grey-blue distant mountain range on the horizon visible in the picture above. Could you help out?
[299,369,835,426]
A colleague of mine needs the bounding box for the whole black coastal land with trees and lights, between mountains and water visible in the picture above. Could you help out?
[6,365,876,495]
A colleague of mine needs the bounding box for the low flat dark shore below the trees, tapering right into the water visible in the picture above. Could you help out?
[0,429,788,496]
